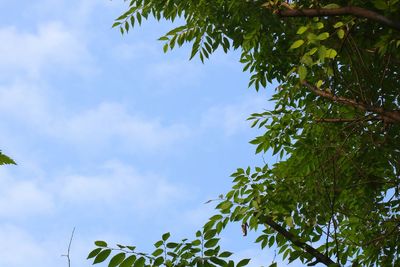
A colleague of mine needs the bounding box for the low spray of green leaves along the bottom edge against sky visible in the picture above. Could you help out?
[88,229,250,267]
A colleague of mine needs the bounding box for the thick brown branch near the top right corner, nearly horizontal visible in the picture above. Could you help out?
[276,6,400,31]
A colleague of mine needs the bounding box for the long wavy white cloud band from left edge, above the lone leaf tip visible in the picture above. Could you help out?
[0,82,190,152]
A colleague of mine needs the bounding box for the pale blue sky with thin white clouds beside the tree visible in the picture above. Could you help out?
[0,0,302,267]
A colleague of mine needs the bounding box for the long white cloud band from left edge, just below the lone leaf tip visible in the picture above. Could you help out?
[0,161,188,219]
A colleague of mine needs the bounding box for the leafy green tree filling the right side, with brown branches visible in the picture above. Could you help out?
[89,0,400,267]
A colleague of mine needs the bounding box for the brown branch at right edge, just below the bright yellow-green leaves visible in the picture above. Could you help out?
[302,81,400,123]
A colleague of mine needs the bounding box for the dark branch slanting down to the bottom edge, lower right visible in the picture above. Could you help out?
[262,216,337,266]
